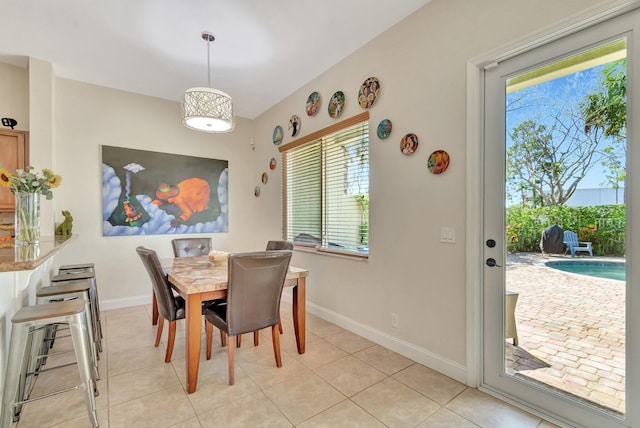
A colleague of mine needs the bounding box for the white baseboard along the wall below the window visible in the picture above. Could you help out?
[282,289,466,384]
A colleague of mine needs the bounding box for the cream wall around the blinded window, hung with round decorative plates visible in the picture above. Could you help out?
[255,0,596,381]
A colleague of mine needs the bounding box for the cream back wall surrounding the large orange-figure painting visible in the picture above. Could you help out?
[53,79,255,309]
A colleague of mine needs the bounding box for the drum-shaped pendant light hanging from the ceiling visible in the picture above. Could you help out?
[182,31,235,132]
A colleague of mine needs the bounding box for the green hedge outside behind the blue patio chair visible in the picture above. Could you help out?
[506,205,626,256]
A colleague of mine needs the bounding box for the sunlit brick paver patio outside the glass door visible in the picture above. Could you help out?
[506,253,625,413]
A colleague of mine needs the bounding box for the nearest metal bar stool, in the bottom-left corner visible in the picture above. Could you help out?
[0,300,98,428]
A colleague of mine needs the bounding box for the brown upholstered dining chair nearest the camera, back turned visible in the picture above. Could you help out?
[203,250,292,385]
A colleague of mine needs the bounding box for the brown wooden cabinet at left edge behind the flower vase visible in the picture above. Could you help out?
[0,128,29,212]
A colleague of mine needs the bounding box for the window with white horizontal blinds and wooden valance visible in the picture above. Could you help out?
[279,112,369,257]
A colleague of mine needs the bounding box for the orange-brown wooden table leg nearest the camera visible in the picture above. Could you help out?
[185,293,202,394]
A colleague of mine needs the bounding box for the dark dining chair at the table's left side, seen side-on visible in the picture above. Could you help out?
[136,246,185,363]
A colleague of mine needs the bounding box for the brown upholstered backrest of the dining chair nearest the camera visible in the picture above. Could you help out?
[227,250,292,336]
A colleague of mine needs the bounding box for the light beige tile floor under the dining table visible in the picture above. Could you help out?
[17,304,554,428]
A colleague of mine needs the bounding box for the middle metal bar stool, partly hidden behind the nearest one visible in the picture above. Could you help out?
[36,279,100,380]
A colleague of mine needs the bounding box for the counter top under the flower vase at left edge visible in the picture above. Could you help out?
[0,235,73,272]
